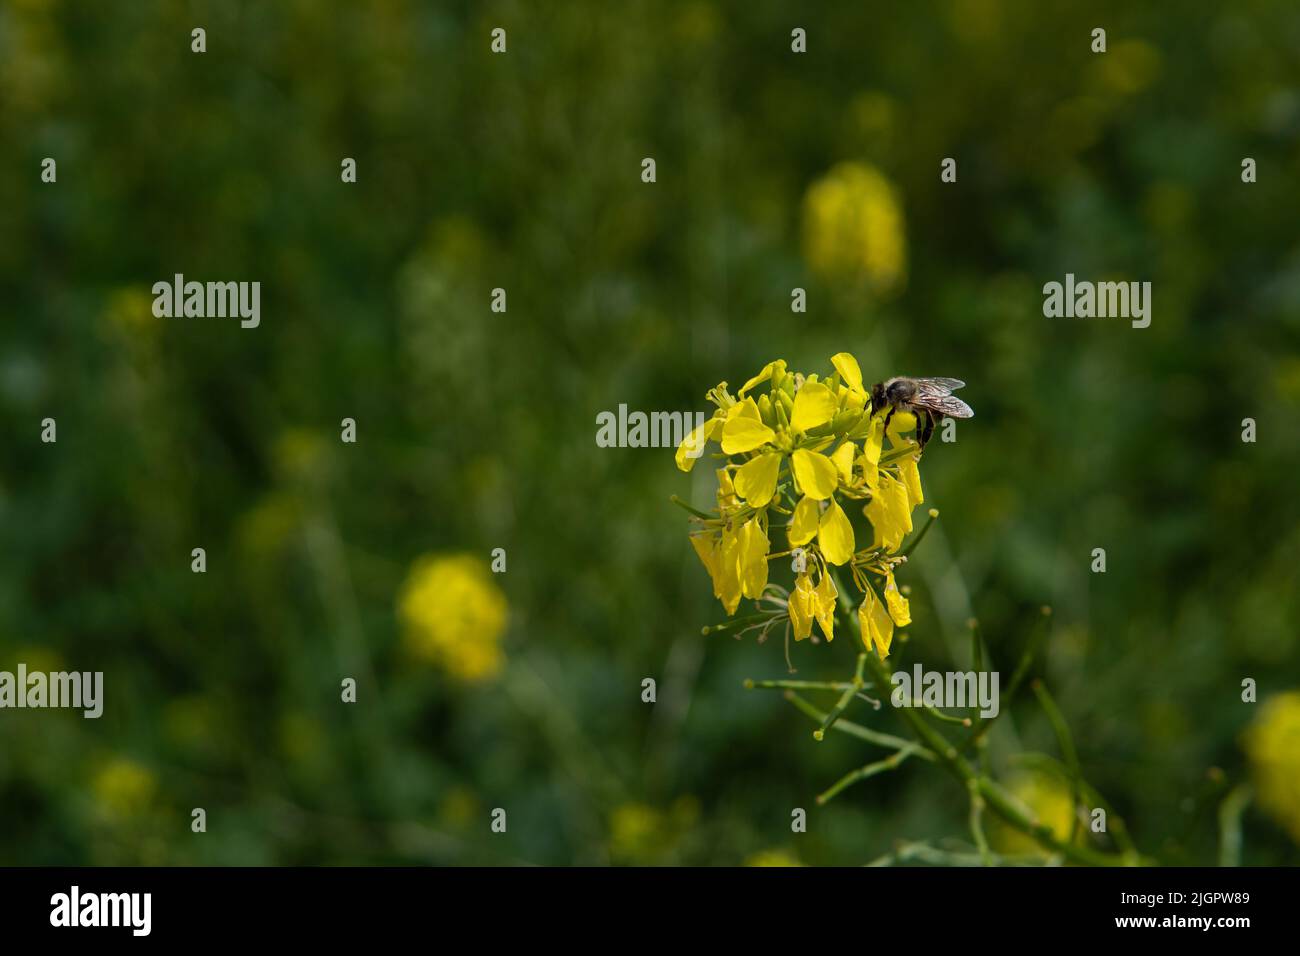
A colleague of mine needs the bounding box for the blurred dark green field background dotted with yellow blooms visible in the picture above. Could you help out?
[0,0,1300,865]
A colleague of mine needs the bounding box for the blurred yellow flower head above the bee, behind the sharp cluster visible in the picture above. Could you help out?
[803,163,907,295]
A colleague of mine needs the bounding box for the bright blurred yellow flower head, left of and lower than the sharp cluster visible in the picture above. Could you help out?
[398,554,507,682]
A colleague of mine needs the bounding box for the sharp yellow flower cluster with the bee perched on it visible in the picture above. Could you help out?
[677,352,924,657]
